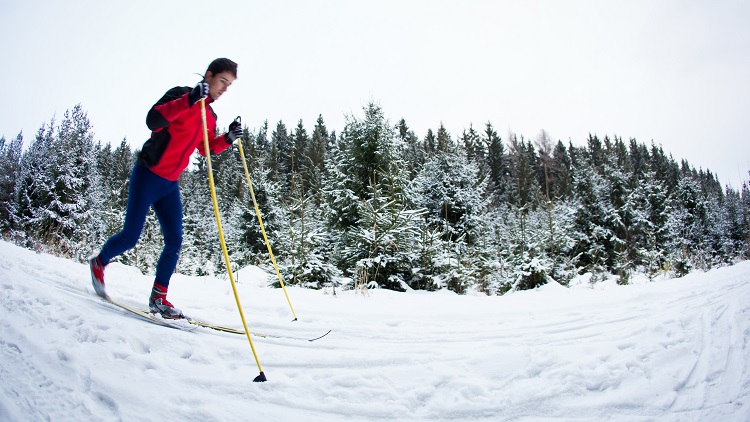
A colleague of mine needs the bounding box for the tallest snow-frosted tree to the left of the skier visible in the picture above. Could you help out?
[17,104,102,260]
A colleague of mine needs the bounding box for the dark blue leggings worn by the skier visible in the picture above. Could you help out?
[99,164,182,287]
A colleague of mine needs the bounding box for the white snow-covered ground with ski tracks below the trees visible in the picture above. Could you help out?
[0,242,750,422]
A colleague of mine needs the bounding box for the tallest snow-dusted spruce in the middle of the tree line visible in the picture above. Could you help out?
[326,103,417,290]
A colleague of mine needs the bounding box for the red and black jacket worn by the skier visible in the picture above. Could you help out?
[138,86,231,180]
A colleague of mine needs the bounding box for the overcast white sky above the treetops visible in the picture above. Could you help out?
[0,0,750,188]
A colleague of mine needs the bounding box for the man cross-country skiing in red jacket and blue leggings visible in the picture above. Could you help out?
[89,58,242,319]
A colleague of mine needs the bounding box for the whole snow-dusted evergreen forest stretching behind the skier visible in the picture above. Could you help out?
[0,103,750,295]
